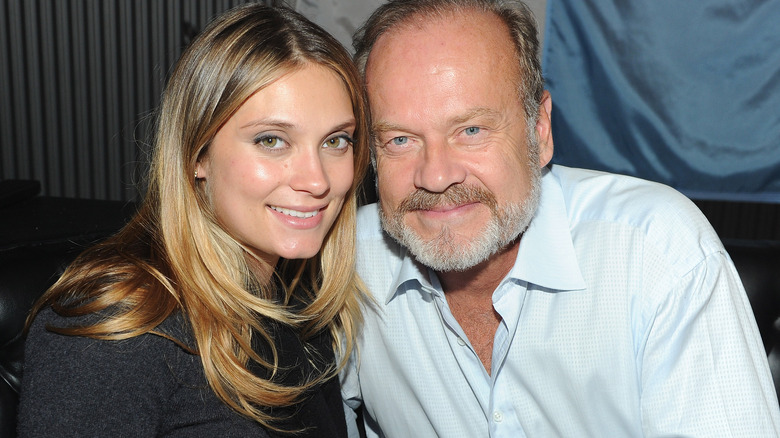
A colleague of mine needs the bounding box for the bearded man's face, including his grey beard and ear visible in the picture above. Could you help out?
[366,9,552,271]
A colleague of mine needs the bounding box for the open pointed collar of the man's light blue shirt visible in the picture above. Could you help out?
[385,168,585,303]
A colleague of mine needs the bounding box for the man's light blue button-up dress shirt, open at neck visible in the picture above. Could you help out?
[342,166,780,438]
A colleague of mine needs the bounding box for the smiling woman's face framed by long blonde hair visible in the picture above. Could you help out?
[197,64,355,266]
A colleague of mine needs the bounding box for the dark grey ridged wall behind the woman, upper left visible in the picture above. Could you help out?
[0,0,264,200]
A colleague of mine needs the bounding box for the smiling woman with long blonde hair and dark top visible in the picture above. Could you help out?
[19,5,368,437]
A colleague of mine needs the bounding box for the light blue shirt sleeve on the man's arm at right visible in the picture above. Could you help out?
[640,252,780,437]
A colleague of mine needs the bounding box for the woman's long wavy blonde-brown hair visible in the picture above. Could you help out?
[28,5,369,429]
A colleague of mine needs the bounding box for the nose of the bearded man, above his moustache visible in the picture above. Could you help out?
[414,139,467,193]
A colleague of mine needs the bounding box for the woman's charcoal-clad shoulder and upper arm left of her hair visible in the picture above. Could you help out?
[19,308,278,436]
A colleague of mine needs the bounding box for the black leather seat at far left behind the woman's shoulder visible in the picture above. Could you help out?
[0,181,134,438]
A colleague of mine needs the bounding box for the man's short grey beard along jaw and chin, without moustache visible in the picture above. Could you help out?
[379,142,542,272]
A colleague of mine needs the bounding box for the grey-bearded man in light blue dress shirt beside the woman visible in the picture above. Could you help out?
[343,0,780,437]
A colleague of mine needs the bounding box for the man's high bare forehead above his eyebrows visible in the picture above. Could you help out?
[366,12,519,116]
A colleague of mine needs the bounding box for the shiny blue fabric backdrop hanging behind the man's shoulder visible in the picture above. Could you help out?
[543,0,780,202]
